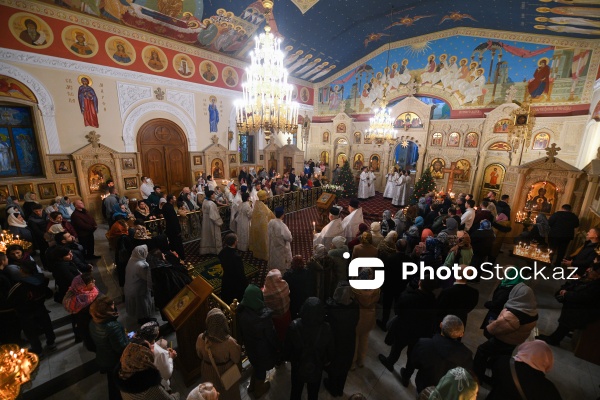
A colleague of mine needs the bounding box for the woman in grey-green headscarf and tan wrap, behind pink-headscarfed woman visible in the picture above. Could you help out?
[473,283,538,382]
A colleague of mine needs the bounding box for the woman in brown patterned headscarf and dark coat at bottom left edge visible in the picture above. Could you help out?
[115,341,179,400]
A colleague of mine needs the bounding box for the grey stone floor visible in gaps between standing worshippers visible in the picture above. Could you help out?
[16,223,600,400]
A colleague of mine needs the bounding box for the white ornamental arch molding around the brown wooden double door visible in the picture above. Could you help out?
[123,101,198,153]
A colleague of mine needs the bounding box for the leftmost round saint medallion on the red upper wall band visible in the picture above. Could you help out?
[8,12,54,49]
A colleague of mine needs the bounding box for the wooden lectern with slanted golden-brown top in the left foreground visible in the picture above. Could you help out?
[163,276,213,385]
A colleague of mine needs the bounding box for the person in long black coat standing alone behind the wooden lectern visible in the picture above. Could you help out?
[219,233,248,304]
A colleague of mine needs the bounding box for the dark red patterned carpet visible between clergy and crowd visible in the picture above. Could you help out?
[185,192,399,286]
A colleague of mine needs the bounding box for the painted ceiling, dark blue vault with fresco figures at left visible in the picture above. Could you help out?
[35,0,600,82]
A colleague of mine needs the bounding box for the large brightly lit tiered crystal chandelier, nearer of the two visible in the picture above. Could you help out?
[235,0,298,144]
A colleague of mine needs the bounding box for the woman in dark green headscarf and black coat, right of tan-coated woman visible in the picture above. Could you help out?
[237,285,280,398]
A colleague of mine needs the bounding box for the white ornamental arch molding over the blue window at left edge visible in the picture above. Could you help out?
[0,57,62,154]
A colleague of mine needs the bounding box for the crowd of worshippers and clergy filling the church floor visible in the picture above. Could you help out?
[0,160,600,400]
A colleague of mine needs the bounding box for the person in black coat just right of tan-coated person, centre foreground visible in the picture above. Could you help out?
[379,280,435,376]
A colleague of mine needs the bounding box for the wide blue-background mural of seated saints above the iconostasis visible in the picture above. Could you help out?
[316,36,592,115]
